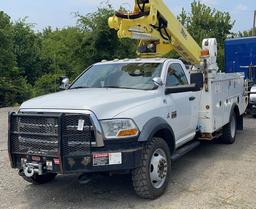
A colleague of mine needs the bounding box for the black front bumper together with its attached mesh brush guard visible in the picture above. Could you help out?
[8,113,142,174]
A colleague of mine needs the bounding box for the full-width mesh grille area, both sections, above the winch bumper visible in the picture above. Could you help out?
[10,114,95,157]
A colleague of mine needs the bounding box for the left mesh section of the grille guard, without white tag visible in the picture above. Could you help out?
[10,114,60,157]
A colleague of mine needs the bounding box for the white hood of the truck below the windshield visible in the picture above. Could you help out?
[20,88,157,119]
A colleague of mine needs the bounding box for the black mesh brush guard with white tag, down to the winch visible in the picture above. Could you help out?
[8,113,96,174]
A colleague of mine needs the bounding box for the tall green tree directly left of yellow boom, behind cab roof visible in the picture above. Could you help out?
[77,5,137,66]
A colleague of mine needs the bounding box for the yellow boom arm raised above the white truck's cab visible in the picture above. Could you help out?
[108,0,201,64]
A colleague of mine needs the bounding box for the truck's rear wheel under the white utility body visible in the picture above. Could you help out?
[221,112,237,144]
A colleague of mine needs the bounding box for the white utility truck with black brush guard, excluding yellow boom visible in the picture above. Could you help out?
[9,58,248,199]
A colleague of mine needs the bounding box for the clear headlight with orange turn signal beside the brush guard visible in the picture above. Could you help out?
[101,119,139,139]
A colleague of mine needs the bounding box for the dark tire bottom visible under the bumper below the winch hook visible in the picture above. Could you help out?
[21,173,57,185]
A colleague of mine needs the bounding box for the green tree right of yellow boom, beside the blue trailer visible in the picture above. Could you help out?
[178,1,235,70]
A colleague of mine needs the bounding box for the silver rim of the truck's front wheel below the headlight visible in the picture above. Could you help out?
[149,148,168,189]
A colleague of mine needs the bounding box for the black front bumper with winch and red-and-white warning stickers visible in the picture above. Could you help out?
[11,147,141,174]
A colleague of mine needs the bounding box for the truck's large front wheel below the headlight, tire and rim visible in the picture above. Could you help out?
[132,137,171,199]
